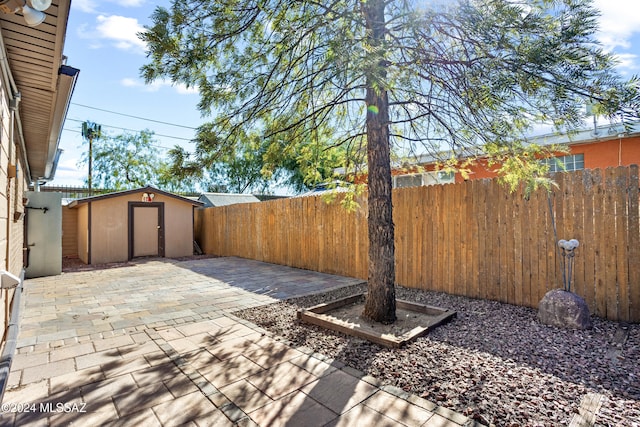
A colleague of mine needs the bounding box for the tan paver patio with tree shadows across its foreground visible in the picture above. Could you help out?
[0,258,474,426]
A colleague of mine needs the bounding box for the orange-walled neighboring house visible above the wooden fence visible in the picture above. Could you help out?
[393,124,640,187]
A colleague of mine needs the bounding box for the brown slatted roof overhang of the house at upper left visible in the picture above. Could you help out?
[0,0,79,182]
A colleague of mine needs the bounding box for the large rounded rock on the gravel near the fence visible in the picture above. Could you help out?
[538,289,592,329]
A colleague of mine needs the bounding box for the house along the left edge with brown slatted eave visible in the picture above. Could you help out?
[0,0,79,370]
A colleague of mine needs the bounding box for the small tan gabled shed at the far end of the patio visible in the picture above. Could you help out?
[68,186,203,264]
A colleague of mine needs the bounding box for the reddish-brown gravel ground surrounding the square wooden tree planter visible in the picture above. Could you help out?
[235,286,640,427]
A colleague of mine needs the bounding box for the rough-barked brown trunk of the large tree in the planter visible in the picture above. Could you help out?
[362,0,396,323]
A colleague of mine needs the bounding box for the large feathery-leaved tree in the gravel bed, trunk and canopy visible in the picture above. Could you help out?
[140,0,635,322]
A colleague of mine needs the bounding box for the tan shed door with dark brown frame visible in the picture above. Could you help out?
[129,203,164,258]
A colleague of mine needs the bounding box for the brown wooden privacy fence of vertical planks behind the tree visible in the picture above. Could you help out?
[196,166,640,322]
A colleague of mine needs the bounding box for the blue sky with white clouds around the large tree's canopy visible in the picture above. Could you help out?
[48,0,640,193]
